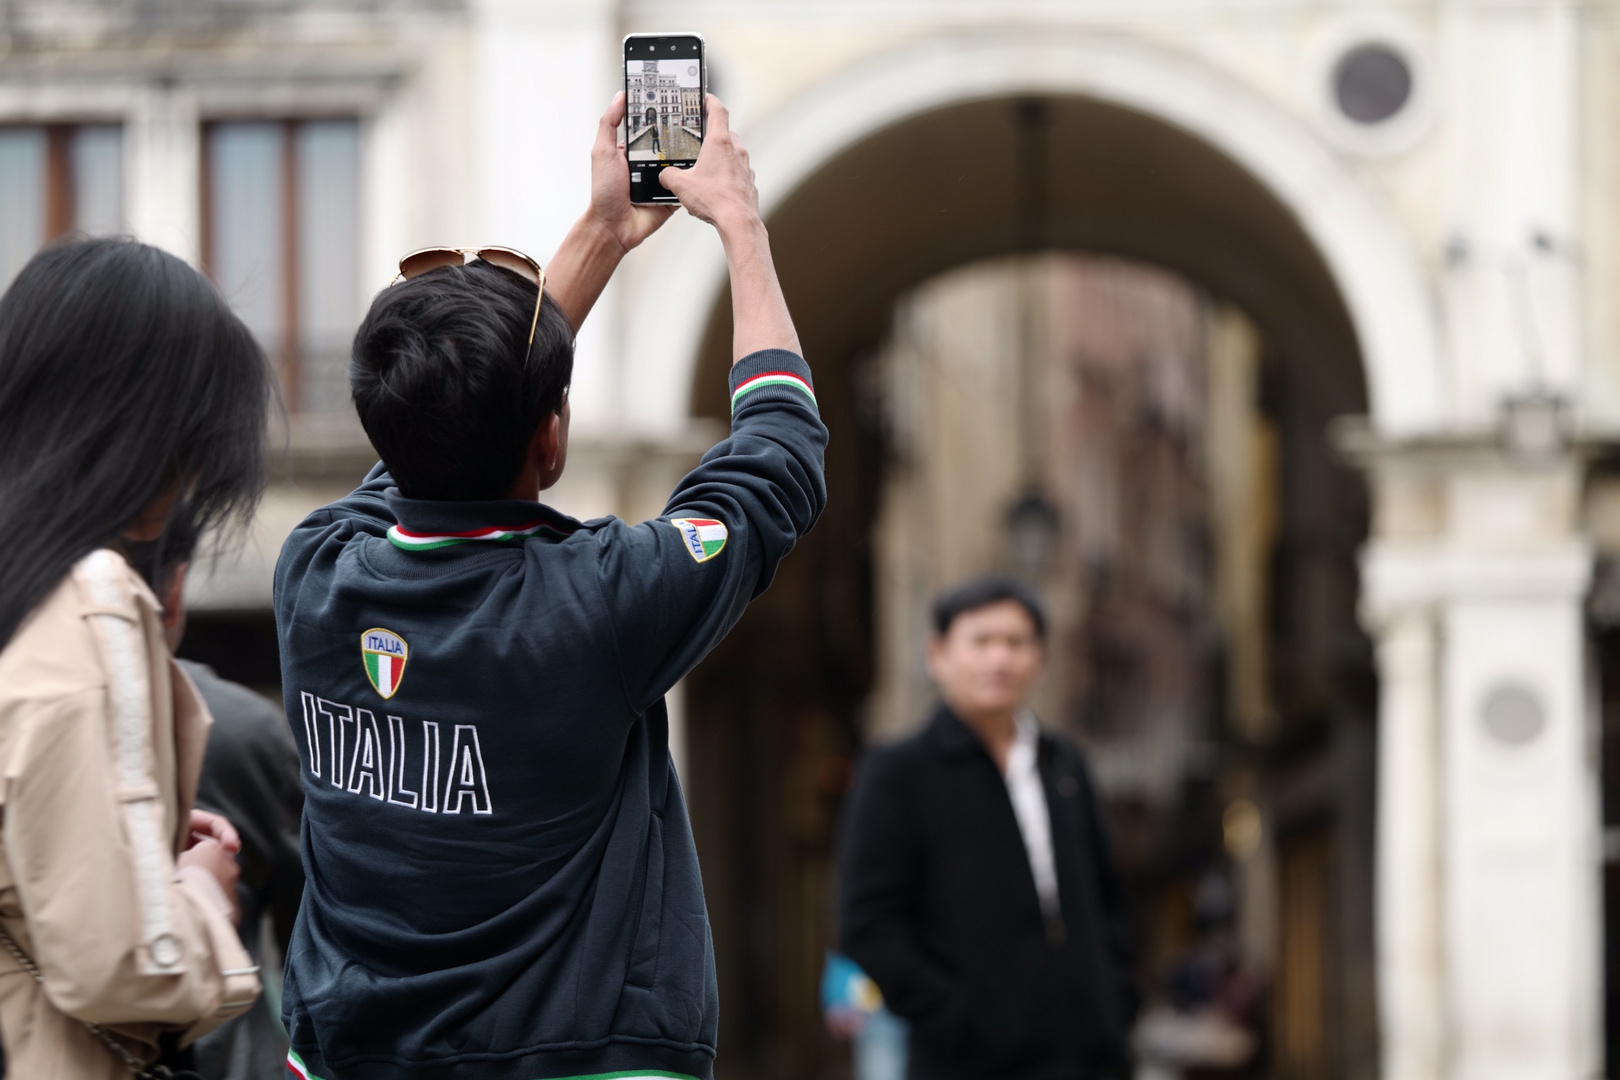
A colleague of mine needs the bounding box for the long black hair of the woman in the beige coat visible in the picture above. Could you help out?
[0,240,272,648]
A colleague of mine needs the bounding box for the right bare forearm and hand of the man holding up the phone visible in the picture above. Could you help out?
[658,94,804,363]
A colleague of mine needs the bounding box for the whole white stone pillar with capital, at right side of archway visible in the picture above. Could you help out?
[1364,439,1602,1080]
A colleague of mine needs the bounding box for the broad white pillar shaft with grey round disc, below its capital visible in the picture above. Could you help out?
[1442,539,1602,1080]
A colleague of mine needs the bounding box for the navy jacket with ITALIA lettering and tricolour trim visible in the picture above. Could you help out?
[275,350,826,1080]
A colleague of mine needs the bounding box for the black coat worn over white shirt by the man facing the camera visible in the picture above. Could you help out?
[839,706,1136,1080]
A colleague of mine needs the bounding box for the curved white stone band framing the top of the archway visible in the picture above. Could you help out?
[625,34,1447,434]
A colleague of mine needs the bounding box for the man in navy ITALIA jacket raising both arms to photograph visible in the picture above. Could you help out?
[275,96,826,1080]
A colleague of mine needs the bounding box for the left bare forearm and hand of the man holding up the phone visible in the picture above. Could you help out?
[546,92,676,334]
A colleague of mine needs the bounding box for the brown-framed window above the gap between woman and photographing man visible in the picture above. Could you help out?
[203,120,360,413]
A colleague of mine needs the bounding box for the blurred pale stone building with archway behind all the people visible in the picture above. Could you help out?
[0,0,1620,1080]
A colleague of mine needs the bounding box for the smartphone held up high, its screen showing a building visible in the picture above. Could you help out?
[624,34,708,202]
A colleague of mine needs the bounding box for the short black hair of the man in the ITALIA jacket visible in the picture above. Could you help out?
[348,261,573,500]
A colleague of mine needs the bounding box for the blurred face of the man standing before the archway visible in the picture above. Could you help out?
[928,601,1045,716]
